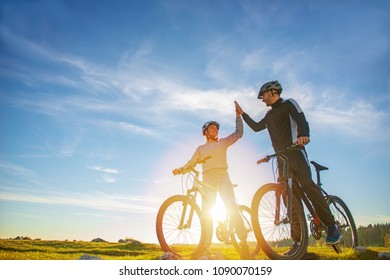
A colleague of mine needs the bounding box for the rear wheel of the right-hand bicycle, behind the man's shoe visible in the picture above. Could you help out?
[326,195,358,253]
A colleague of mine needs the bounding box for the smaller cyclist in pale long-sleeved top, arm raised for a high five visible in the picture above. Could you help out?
[173,103,249,259]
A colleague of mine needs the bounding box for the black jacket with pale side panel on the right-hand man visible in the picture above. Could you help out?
[242,98,310,152]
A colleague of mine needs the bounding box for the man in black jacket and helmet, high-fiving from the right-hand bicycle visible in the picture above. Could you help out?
[237,81,341,249]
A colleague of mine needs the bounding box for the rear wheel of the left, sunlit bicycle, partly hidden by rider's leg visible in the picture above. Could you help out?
[229,205,261,258]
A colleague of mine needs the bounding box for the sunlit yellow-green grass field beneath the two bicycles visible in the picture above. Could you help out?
[0,239,390,260]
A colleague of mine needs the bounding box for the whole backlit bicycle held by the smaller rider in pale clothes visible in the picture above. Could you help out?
[156,158,260,259]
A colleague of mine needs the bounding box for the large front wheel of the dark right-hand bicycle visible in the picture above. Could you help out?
[251,183,309,260]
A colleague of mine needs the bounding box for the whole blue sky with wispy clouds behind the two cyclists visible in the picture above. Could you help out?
[0,0,390,242]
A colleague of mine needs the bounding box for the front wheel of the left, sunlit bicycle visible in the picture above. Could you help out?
[156,195,205,259]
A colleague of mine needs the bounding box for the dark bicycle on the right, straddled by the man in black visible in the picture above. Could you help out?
[251,144,358,260]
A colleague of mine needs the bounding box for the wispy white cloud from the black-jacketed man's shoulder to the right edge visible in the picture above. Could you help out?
[286,83,390,141]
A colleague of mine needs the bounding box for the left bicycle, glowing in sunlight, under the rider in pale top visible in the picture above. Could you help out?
[156,157,260,259]
